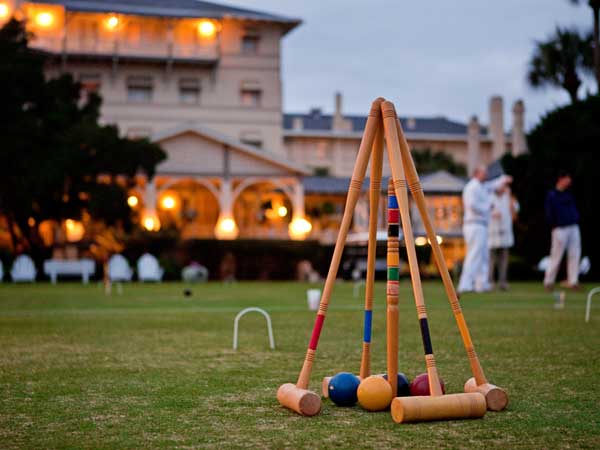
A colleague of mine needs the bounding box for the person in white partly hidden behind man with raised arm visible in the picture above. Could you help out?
[488,185,519,291]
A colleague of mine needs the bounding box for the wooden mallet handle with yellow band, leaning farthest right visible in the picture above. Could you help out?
[396,120,487,385]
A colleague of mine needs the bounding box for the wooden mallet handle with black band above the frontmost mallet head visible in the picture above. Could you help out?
[381,102,442,396]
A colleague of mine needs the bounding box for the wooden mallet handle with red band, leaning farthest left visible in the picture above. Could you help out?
[296,98,383,389]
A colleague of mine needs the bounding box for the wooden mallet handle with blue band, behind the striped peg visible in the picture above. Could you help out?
[360,125,383,378]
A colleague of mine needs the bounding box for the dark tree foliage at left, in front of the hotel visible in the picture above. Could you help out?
[0,20,166,251]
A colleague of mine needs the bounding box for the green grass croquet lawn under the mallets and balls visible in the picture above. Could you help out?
[0,280,600,449]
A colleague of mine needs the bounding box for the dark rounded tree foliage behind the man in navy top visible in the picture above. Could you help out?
[503,96,600,276]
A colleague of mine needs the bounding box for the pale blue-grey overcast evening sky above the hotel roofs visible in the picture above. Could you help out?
[221,0,593,128]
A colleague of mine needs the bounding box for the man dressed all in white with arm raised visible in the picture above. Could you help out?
[458,166,512,293]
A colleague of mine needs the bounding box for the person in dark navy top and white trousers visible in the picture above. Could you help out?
[544,171,581,290]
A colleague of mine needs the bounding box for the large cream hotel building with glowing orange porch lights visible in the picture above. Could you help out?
[0,0,526,268]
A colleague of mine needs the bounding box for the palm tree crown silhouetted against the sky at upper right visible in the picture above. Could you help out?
[527,28,591,103]
